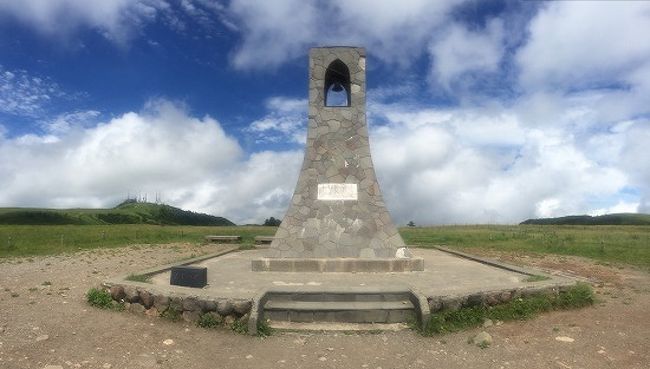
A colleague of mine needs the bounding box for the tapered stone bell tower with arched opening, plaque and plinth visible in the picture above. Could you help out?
[252,47,423,272]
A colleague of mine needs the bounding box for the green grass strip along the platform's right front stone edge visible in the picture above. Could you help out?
[422,283,594,336]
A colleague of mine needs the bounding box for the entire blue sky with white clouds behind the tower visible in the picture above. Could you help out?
[0,0,650,225]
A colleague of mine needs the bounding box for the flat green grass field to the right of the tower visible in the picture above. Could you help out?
[400,225,650,268]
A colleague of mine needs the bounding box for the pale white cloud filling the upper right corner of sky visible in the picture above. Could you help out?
[516,1,650,90]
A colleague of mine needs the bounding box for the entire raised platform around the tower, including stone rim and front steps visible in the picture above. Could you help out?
[105,247,576,334]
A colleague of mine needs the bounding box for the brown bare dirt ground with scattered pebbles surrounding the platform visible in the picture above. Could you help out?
[0,244,650,369]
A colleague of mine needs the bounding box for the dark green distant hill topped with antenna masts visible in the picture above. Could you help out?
[0,200,235,226]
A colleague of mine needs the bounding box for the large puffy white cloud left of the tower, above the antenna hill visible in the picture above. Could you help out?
[0,100,302,222]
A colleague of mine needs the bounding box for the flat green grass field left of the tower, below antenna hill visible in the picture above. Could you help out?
[0,224,277,257]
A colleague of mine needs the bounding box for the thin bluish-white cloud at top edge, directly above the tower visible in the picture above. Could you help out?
[229,0,459,69]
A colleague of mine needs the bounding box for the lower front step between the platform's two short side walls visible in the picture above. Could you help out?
[264,300,416,323]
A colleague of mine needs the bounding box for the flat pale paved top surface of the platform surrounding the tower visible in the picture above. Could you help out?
[146,249,569,299]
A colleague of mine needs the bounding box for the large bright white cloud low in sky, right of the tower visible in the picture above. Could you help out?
[371,103,632,224]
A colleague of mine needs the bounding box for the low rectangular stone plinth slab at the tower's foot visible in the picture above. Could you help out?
[251,257,424,273]
